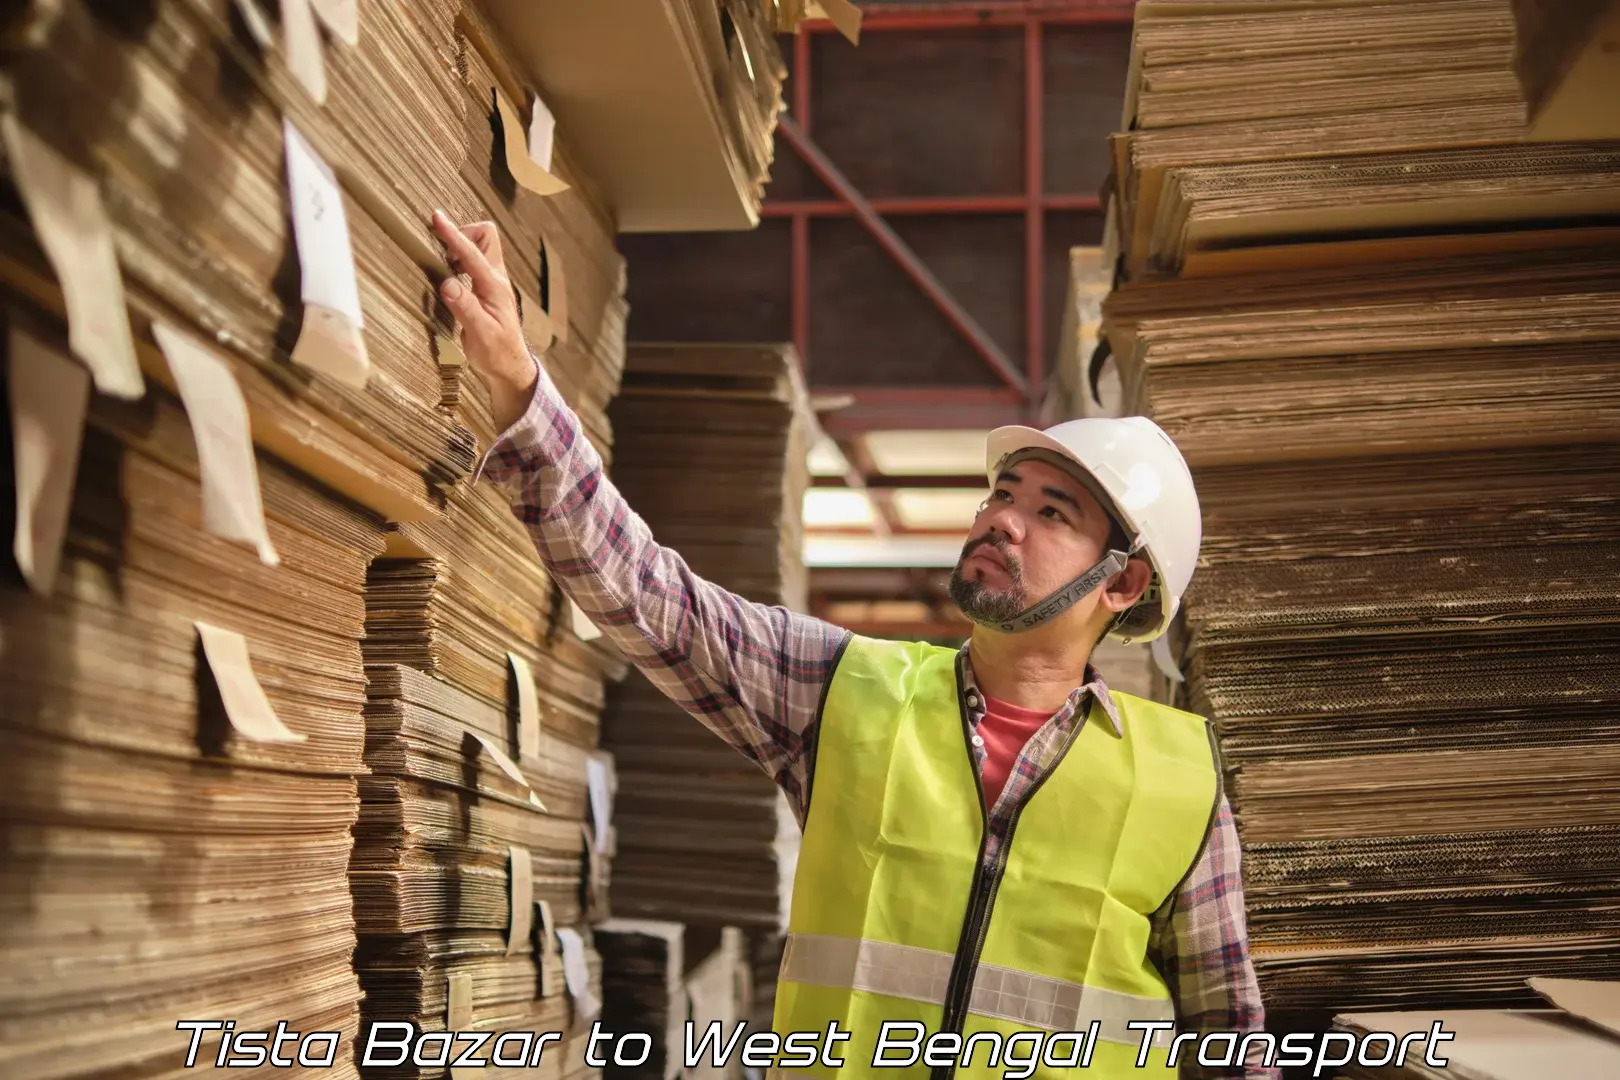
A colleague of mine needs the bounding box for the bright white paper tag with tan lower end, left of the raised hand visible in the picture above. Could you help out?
[284,120,371,387]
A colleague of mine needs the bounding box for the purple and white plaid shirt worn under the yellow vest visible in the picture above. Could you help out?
[475,366,1280,1080]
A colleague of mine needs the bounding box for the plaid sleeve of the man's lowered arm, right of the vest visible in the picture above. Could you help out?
[1152,795,1281,1080]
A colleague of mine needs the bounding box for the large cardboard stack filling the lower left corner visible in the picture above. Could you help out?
[0,320,384,1077]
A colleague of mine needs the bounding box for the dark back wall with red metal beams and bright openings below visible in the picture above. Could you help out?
[624,0,1136,640]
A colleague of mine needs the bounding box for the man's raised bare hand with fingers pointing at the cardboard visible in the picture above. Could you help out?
[433,210,538,431]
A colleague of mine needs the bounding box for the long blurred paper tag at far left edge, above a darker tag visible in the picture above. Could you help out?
[0,112,146,400]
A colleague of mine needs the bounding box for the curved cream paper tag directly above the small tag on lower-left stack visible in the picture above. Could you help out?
[152,322,280,567]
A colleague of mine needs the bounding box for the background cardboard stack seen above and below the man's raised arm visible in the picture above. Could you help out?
[603,345,810,928]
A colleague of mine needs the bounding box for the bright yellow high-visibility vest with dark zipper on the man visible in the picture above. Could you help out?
[770,636,1220,1080]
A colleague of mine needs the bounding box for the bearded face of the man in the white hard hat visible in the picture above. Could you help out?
[951,461,1111,622]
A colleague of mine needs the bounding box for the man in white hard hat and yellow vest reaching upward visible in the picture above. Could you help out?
[434,214,1277,1080]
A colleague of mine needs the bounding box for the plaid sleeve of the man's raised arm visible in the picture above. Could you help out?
[475,363,849,814]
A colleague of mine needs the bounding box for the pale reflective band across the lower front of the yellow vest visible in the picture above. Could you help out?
[781,934,1176,1046]
